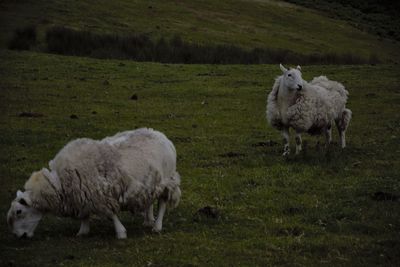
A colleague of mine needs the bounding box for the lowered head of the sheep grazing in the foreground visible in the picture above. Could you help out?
[7,191,42,237]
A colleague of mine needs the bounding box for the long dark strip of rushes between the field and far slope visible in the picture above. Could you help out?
[39,27,379,64]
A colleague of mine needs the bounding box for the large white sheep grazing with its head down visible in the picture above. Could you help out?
[7,128,181,238]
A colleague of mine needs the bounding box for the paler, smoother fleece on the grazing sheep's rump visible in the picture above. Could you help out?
[102,128,179,213]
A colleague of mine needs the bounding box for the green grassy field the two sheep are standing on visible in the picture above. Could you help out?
[0,51,400,266]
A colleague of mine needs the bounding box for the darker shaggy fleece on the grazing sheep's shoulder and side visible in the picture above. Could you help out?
[50,138,126,217]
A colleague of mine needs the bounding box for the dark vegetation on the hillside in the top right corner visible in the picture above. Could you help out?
[286,0,400,41]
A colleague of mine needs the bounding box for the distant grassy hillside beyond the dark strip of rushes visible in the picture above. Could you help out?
[0,0,400,62]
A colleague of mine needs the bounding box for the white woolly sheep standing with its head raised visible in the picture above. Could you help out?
[267,64,352,156]
